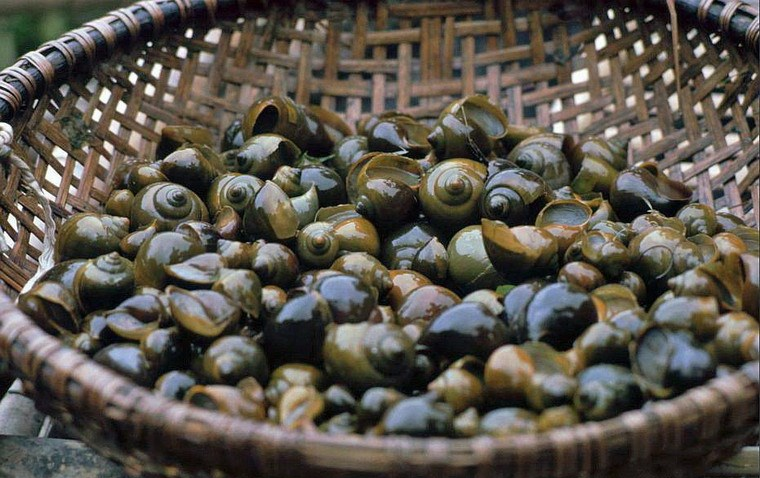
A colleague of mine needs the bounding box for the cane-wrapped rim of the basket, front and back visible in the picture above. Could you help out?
[0,0,760,476]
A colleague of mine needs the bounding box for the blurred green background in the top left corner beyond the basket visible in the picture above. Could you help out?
[0,0,132,68]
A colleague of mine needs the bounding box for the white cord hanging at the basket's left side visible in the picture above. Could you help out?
[0,123,56,293]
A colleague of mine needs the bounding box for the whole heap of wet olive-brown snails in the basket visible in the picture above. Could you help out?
[19,96,760,437]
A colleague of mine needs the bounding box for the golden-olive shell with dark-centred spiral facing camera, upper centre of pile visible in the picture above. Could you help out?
[419,159,486,231]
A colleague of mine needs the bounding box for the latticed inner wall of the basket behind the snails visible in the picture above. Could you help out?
[0,0,760,291]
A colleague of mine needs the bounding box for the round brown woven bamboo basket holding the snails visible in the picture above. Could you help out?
[0,0,760,478]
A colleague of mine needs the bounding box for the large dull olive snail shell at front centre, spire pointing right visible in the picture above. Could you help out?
[323,322,414,392]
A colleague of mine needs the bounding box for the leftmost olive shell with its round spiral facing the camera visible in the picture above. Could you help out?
[131,182,208,231]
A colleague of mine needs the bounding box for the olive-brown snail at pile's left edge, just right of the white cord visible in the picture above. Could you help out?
[54,213,130,262]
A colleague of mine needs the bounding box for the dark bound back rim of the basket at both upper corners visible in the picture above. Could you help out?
[0,0,760,121]
